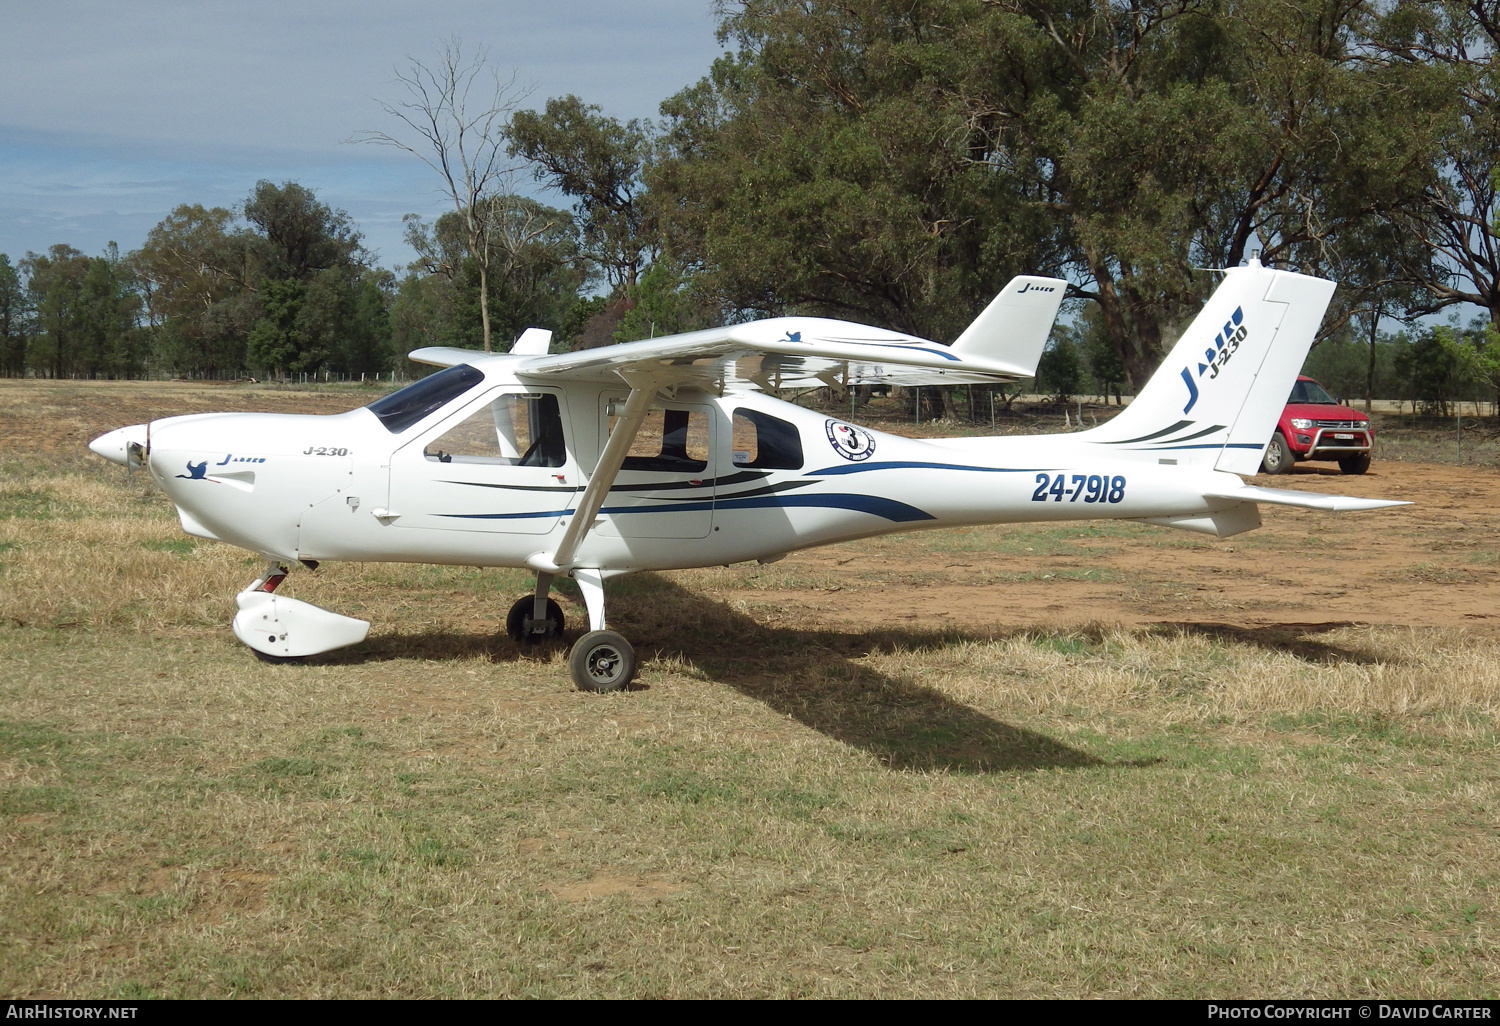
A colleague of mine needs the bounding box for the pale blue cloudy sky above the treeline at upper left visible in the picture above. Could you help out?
[0,0,722,267]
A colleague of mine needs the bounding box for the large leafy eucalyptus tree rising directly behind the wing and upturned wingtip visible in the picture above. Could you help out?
[650,0,1062,345]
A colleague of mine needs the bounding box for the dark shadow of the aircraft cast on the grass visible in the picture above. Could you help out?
[314,573,1160,774]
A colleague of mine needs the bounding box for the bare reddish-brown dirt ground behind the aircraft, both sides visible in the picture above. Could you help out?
[0,381,1500,632]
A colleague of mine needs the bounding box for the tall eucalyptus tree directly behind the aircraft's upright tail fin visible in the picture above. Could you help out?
[962,0,1434,386]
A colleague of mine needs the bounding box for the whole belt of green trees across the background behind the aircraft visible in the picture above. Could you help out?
[11,0,1500,384]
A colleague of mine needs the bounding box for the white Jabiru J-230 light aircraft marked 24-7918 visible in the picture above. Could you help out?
[90,261,1400,692]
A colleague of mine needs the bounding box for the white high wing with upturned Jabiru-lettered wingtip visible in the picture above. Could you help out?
[411,276,1067,392]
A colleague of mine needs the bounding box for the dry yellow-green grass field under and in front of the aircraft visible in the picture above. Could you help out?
[0,381,1500,998]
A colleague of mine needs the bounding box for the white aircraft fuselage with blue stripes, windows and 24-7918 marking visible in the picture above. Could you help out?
[122,369,1259,573]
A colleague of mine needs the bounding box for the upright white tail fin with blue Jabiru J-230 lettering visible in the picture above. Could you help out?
[1088,261,1335,474]
